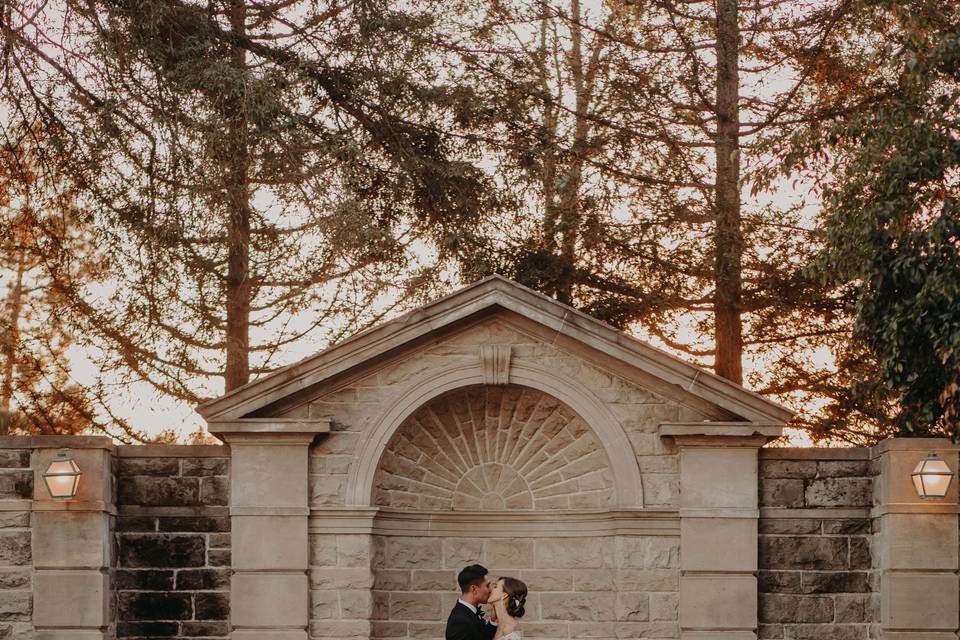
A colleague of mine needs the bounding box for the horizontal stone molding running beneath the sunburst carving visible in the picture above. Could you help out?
[310,509,680,538]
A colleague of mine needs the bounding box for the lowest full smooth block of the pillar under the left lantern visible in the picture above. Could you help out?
[33,571,110,627]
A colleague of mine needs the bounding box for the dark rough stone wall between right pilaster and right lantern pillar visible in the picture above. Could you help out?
[759,449,879,640]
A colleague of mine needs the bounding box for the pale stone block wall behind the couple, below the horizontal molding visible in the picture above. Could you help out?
[310,521,679,639]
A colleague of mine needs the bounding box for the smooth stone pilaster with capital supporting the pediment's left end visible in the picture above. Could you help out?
[210,419,330,640]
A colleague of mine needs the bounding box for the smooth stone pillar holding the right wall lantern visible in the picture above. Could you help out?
[873,438,960,640]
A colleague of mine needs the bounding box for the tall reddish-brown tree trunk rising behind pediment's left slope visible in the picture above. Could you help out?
[224,0,252,391]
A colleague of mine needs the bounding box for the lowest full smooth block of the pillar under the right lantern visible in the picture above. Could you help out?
[880,573,960,631]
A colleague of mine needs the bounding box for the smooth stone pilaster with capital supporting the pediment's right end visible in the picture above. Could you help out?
[660,423,781,640]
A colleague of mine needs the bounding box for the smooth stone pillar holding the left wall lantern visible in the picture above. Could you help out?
[30,436,116,640]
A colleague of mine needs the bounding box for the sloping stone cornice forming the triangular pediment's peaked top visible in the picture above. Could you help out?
[198,275,793,424]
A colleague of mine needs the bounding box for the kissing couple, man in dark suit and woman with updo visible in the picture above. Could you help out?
[446,564,527,640]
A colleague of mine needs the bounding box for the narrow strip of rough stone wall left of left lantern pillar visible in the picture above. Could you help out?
[0,449,33,640]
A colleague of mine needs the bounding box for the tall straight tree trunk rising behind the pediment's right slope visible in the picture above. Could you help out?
[714,0,743,384]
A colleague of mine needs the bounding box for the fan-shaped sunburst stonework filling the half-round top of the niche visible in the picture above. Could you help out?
[374,386,613,511]
